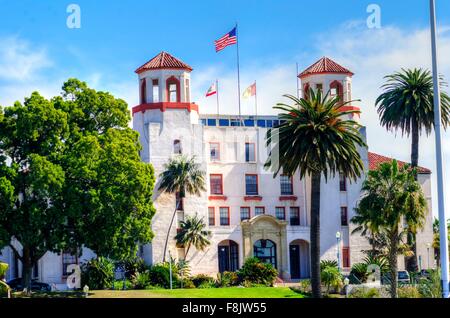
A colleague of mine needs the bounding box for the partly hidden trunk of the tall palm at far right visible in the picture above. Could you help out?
[405,117,419,272]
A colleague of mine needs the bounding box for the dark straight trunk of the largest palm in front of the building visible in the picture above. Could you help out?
[310,172,322,298]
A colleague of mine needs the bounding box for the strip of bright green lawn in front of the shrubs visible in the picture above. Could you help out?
[89,287,305,298]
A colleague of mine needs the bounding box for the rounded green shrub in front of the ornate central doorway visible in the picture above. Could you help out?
[238,257,278,286]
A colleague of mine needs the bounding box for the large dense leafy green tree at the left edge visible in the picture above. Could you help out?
[0,79,154,287]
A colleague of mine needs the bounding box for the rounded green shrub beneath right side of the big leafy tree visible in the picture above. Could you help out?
[81,257,114,290]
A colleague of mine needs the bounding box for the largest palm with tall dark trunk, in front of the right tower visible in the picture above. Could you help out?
[265,90,365,298]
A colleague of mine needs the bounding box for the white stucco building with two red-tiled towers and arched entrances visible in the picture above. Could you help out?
[0,52,434,286]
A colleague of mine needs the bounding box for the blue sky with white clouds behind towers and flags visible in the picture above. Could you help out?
[0,0,450,217]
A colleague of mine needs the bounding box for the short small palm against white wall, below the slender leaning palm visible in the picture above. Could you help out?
[175,214,211,259]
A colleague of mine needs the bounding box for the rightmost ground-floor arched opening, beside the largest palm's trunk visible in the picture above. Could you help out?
[289,240,311,279]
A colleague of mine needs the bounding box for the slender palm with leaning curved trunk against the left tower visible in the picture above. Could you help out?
[159,156,206,262]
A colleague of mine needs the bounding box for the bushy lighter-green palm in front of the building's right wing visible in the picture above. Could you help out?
[351,160,427,298]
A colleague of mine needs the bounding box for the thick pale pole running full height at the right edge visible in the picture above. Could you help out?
[430,0,449,298]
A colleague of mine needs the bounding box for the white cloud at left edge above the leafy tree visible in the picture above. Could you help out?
[0,37,51,81]
